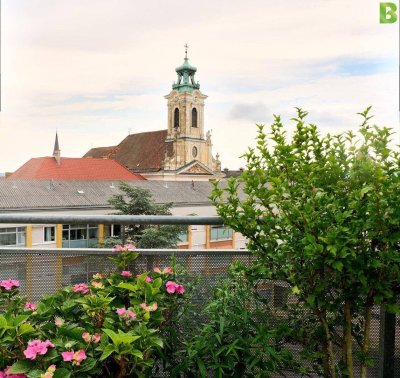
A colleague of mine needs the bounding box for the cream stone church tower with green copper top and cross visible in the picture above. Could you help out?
[164,45,221,173]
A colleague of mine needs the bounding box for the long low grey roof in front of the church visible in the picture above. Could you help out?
[0,179,239,211]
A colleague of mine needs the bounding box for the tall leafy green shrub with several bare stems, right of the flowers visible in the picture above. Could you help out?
[212,108,400,378]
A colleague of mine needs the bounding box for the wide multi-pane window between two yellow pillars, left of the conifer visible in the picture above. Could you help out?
[62,224,98,248]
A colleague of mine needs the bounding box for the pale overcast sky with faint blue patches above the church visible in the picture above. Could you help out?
[0,0,399,172]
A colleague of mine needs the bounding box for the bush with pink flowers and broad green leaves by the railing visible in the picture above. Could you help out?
[0,245,185,378]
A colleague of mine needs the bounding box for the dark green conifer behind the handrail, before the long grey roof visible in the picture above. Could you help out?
[105,182,185,248]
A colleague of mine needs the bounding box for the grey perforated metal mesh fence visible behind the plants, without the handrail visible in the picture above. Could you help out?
[0,249,400,378]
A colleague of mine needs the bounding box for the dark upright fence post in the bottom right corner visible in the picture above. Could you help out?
[378,307,396,378]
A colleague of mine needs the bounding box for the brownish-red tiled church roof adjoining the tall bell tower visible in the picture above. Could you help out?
[84,130,173,172]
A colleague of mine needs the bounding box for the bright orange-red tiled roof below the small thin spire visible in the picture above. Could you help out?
[7,157,145,180]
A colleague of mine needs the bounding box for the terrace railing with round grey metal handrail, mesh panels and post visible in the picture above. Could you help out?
[0,214,400,378]
